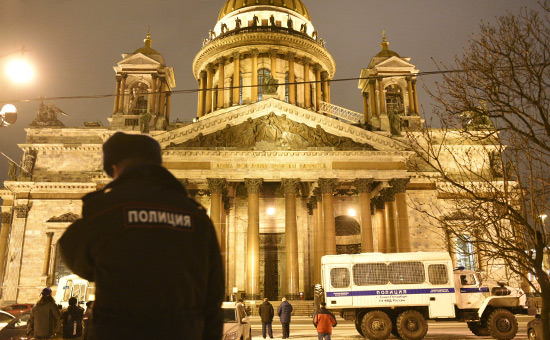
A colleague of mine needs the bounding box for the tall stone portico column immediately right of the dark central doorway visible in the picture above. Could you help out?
[281,178,300,299]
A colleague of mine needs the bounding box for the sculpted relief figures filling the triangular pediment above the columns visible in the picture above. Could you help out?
[175,112,374,150]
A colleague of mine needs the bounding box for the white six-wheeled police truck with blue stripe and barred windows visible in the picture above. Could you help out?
[321,252,526,340]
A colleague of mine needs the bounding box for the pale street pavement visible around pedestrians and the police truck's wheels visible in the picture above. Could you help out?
[250,316,532,340]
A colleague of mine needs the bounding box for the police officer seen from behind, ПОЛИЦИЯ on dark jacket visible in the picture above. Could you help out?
[59,132,225,340]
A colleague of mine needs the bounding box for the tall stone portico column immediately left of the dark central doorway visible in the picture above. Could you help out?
[245,178,263,300]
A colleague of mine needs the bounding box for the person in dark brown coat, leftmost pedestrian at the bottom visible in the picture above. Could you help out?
[27,288,59,339]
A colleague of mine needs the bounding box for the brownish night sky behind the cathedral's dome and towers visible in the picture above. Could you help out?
[0,0,538,187]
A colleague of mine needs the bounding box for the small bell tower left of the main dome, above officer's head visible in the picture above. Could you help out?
[109,31,176,133]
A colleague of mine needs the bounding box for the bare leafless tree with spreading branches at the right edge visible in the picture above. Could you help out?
[408,4,550,339]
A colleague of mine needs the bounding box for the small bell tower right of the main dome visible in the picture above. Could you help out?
[359,31,423,135]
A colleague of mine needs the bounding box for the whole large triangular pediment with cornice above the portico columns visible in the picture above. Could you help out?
[154,98,406,151]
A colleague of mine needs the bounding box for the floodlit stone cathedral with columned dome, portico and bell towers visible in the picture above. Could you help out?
[0,0,492,303]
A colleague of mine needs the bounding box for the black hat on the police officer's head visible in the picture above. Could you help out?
[103,132,162,177]
